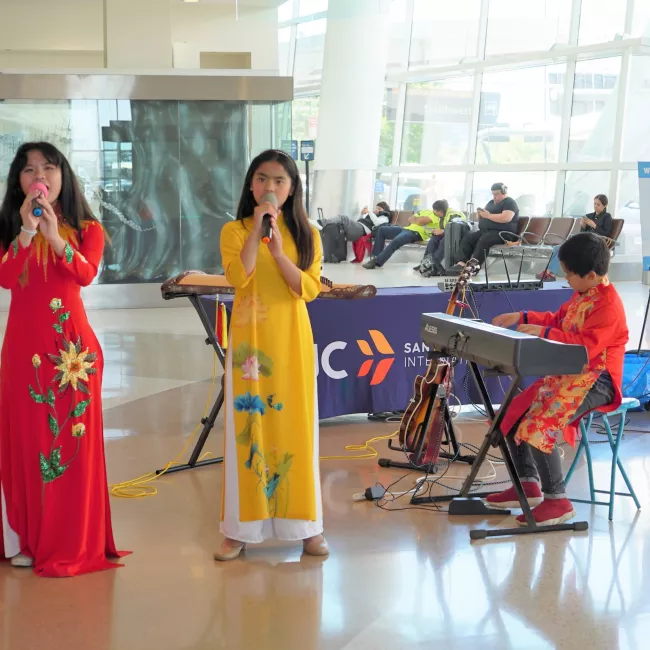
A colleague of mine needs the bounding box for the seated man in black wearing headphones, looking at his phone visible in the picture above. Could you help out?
[450,183,519,273]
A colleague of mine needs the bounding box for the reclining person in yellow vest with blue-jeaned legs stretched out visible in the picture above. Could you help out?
[363,201,454,269]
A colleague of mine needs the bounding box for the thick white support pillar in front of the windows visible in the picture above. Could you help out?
[310,0,390,218]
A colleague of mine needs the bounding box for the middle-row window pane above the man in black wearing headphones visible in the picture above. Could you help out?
[476,64,566,164]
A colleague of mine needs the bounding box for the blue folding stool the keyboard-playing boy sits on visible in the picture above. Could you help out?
[565,397,641,521]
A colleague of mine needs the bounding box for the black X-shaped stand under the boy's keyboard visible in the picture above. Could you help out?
[411,362,589,539]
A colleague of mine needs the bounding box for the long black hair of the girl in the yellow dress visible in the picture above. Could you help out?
[237,149,314,271]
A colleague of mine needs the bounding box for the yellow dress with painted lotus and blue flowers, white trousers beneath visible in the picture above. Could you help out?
[221,216,323,543]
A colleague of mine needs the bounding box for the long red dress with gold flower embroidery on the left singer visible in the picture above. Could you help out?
[0,221,127,577]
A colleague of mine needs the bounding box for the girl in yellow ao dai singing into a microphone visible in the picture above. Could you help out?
[214,150,329,560]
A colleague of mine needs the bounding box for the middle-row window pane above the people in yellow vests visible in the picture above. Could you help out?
[401,77,474,165]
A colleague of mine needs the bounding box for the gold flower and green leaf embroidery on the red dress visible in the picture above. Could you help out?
[29,298,97,483]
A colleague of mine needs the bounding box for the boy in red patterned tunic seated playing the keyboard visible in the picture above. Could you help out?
[486,233,629,526]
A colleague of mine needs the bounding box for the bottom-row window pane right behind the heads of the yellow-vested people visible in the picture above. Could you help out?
[395,172,465,212]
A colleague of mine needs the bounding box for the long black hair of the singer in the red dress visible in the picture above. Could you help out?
[0,142,97,250]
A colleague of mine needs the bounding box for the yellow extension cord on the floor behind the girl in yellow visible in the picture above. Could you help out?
[108,353,399,499]
